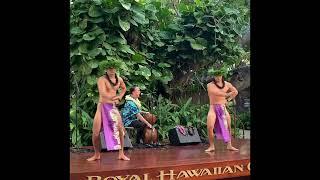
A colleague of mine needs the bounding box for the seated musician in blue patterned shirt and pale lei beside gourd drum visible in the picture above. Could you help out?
[121,86,153,144]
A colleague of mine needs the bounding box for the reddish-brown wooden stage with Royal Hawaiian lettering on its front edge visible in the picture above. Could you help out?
[70,139,250,180]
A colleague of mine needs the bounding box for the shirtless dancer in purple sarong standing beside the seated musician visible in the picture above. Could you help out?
[87,62,130,161]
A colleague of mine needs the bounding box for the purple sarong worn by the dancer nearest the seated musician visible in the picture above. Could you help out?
[101,103,121,150]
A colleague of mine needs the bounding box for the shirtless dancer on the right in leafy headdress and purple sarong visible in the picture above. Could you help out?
[205,69,238,152]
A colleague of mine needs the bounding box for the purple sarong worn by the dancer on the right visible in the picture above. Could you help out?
[213,104,230,142]
